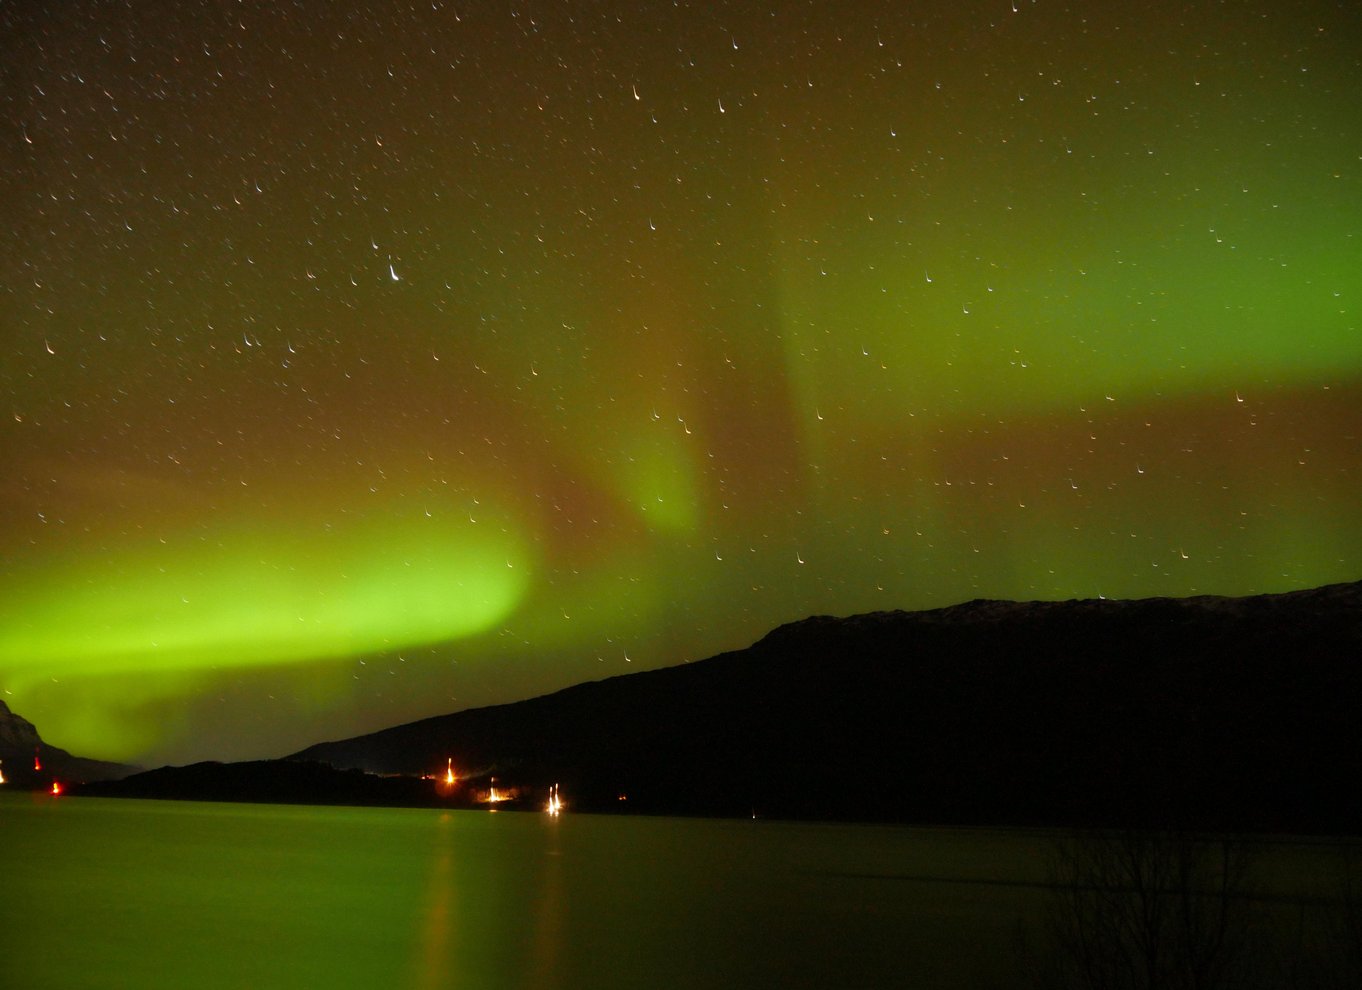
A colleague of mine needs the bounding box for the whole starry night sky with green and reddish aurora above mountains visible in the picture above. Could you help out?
[0,0,1362,764]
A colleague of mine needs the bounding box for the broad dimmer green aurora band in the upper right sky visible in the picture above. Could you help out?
[782,197,1362,419]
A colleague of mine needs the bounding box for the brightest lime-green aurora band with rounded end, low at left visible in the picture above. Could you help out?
[0,515,528,675]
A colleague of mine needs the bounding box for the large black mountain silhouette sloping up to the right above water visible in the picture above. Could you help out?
[271,583,1362,832]
